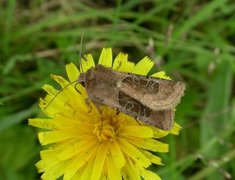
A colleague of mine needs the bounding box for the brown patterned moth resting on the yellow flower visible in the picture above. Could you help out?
[78,65,185,130]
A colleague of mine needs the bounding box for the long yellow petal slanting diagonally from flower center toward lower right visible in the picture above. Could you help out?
[118,138,151,167]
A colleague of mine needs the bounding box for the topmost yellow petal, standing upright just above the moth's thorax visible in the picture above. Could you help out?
[99,48,113,67]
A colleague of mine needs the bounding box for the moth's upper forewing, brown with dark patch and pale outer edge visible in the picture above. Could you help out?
[117,73,185,111]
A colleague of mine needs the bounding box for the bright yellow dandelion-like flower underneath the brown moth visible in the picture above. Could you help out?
[29,48,180,180]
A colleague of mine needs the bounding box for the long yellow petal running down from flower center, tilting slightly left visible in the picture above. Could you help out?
[90,143,107,180]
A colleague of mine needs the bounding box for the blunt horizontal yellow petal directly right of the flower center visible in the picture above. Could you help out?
[122,126,153,138]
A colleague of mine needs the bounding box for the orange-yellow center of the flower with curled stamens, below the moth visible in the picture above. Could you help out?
[93,110,121,141]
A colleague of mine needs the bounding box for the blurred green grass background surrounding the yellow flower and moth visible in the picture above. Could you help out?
[0,0,235,180]
